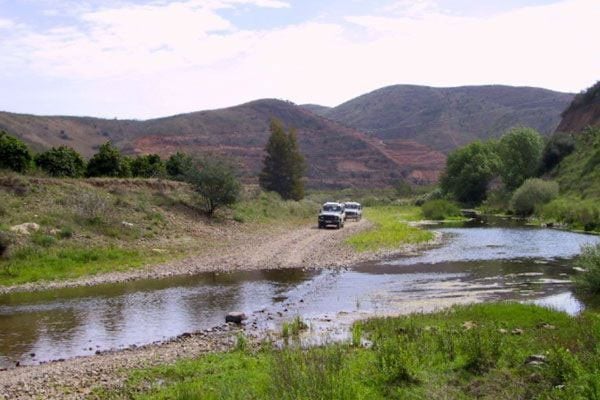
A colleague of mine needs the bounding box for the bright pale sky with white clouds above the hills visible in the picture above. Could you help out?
[0,0,600,119]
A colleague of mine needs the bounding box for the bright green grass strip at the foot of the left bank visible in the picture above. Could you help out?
[0,246,165,286]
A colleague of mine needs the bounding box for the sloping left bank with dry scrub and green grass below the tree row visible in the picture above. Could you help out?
[0,177,318,285]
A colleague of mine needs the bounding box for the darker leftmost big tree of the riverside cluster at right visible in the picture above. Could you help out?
[440,141,500,205]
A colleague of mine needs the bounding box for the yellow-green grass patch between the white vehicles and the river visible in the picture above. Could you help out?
[347,206,433,252]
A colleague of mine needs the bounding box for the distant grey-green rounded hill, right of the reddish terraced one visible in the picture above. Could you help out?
[324,85,573,153]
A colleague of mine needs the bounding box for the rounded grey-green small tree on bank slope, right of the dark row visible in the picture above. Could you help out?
[185,158,241,215]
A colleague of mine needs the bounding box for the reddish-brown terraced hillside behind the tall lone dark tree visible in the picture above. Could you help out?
[0,100,445,187]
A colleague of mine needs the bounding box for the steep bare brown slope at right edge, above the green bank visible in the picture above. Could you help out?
[556,81,600,132]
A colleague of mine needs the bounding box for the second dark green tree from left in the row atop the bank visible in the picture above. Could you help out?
[35,146,85,178]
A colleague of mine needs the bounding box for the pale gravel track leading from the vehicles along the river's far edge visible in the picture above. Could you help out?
[0,219,372,294]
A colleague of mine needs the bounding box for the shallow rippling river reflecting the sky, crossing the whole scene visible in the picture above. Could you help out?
[0,226,600,367]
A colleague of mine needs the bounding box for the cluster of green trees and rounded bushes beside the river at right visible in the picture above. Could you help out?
[440,127,575,216]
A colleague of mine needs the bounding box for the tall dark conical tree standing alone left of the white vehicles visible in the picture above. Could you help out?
[259,119,305,200]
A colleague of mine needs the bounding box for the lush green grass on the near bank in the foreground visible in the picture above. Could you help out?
[97,303,600,399]
